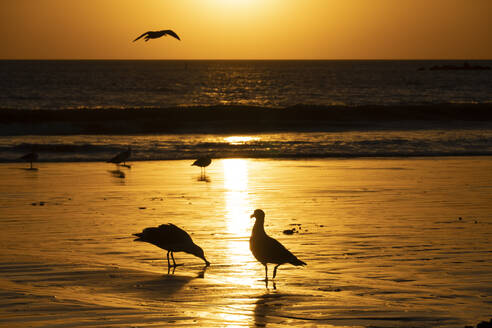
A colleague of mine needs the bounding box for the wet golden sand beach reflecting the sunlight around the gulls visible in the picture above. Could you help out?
[0,157,492,327]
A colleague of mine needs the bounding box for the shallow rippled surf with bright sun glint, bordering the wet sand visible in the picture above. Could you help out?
[0,128,492,162]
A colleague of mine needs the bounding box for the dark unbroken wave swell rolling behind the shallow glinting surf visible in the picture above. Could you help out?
[0,104,492,135]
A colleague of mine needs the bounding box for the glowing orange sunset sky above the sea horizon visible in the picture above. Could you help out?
[0,0,492,59]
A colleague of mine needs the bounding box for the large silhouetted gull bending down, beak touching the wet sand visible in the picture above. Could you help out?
[133,223,210,268]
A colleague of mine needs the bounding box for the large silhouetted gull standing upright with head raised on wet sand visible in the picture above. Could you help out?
[249,209,306,281]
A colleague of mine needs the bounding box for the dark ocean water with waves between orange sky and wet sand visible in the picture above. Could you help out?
[0,60,492,162]
